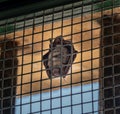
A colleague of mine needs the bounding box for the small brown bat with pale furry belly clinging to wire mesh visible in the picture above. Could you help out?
[43,36,77,78]
